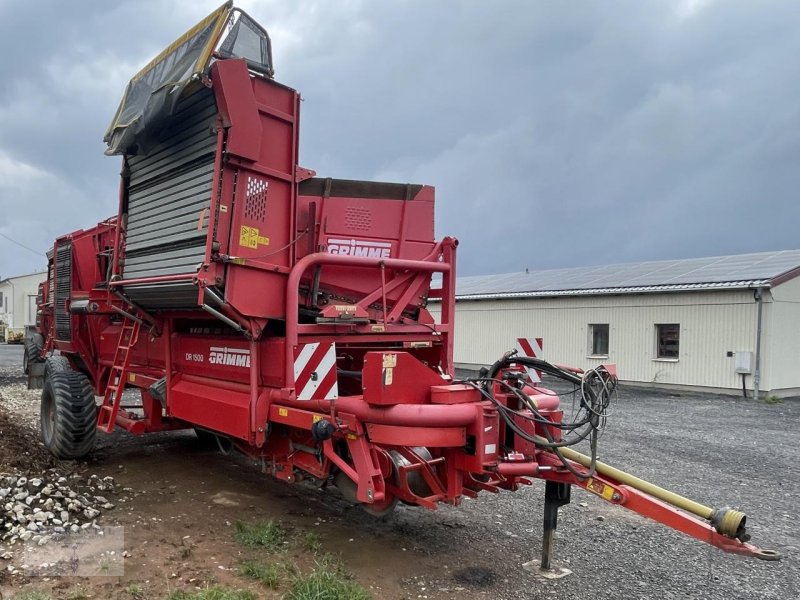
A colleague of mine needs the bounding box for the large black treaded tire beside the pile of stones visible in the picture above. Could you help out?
[40,371,97,459]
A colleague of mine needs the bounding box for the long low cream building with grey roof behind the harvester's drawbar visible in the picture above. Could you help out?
[430,250,800,396]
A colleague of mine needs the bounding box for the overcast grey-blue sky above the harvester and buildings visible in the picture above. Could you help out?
[0,0,800,277]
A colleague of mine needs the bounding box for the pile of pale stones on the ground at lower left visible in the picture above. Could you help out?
[0,469,125,560]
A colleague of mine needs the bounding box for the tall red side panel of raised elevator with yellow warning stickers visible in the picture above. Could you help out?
[211,61,299,318]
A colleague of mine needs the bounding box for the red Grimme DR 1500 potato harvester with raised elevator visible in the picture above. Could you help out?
[26,3,779,569]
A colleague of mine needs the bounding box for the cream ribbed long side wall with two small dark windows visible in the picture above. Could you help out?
[429,284,768,390]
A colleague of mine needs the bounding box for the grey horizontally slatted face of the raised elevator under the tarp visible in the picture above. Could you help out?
[123,88,217,308]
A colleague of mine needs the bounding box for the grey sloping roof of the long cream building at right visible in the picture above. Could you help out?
[438,250,800,300]
